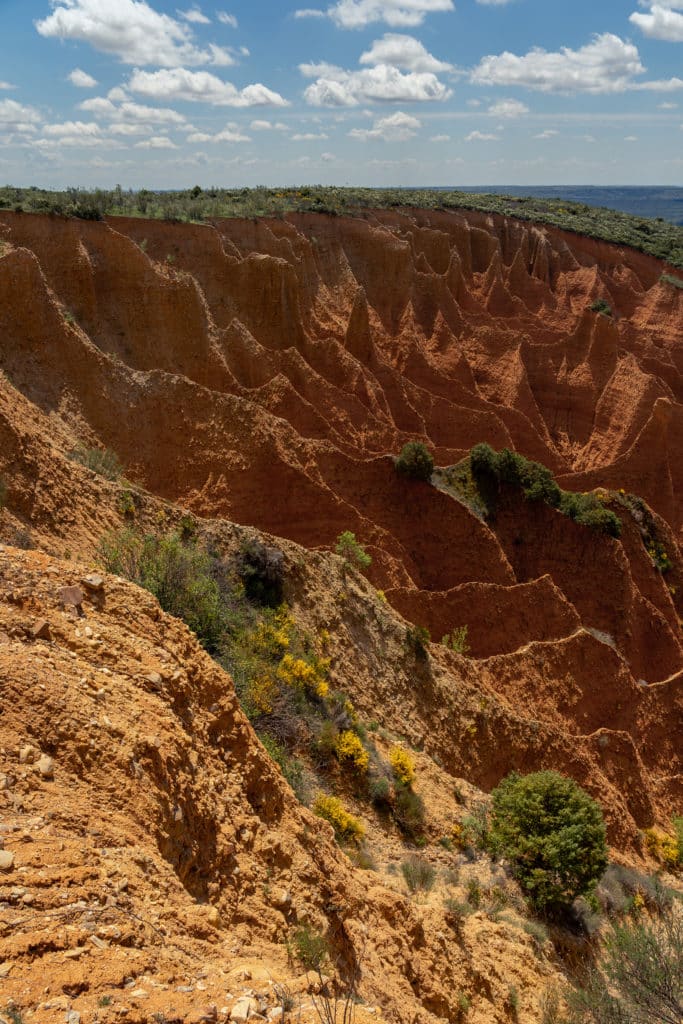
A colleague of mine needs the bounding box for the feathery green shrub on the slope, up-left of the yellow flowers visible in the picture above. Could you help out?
[99,529,224,652]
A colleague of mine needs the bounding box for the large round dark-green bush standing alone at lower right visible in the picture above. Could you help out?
[489,771,607,914]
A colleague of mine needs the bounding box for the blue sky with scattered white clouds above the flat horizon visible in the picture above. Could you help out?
[0,0,683,188]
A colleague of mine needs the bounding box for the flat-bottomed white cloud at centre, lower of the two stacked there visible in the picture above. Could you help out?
[299,63,452,106]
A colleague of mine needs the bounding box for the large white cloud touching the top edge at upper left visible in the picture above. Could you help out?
[36,0,234,68]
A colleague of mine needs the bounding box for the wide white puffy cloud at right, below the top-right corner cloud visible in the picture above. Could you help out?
[471,33,645,93]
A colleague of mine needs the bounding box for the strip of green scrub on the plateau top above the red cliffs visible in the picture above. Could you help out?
[0,185,683,268]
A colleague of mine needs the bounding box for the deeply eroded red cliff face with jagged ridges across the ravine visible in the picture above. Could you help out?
[0,210,683,837]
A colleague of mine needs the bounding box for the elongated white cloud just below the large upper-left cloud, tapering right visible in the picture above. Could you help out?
[128,68,289,106]
